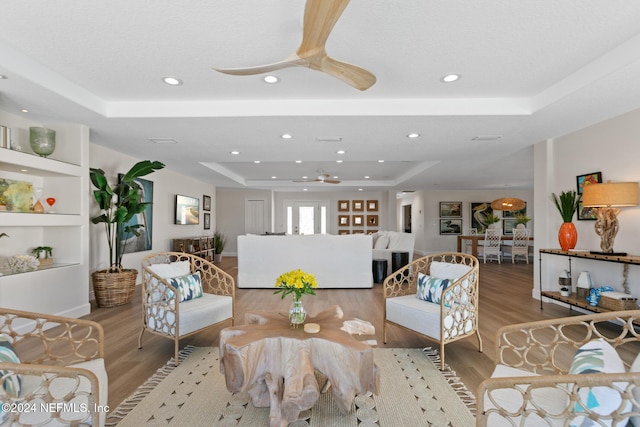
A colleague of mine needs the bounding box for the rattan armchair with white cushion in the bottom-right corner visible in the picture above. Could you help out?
[476,310,640,427]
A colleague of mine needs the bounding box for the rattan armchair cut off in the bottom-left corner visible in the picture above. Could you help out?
[0,308,108,426]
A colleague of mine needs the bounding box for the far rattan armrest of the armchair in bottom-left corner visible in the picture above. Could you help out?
[0,308,105,365]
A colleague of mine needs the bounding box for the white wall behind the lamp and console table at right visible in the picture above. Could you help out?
[533,110,640,304]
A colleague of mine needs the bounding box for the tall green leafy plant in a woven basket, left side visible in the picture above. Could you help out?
[89,160,164,307]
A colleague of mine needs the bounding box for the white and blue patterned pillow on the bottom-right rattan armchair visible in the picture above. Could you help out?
[569,338,631,427]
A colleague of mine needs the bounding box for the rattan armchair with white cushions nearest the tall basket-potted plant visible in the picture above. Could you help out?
[138,252,235,365]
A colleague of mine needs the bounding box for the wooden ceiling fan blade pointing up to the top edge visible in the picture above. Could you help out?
[297,0,349,58]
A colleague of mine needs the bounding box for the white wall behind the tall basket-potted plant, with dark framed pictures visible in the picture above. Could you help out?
[87,144,217,290]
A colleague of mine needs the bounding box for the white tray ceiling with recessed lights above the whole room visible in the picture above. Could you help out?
[0,0,640,191]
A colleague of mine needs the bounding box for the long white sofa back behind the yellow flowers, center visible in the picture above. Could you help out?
[237,234,373,288]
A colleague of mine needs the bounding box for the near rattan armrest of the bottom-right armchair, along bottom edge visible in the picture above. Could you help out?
[476,372,640,427]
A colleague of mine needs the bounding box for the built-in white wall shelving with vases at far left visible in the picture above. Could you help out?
[0,111,90,317]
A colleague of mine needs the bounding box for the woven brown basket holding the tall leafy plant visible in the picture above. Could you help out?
[91,269,138,307]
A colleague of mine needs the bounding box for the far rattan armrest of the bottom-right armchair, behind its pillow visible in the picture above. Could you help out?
[495,310,640,374]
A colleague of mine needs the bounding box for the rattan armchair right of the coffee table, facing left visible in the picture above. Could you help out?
[382,252,482,369]
